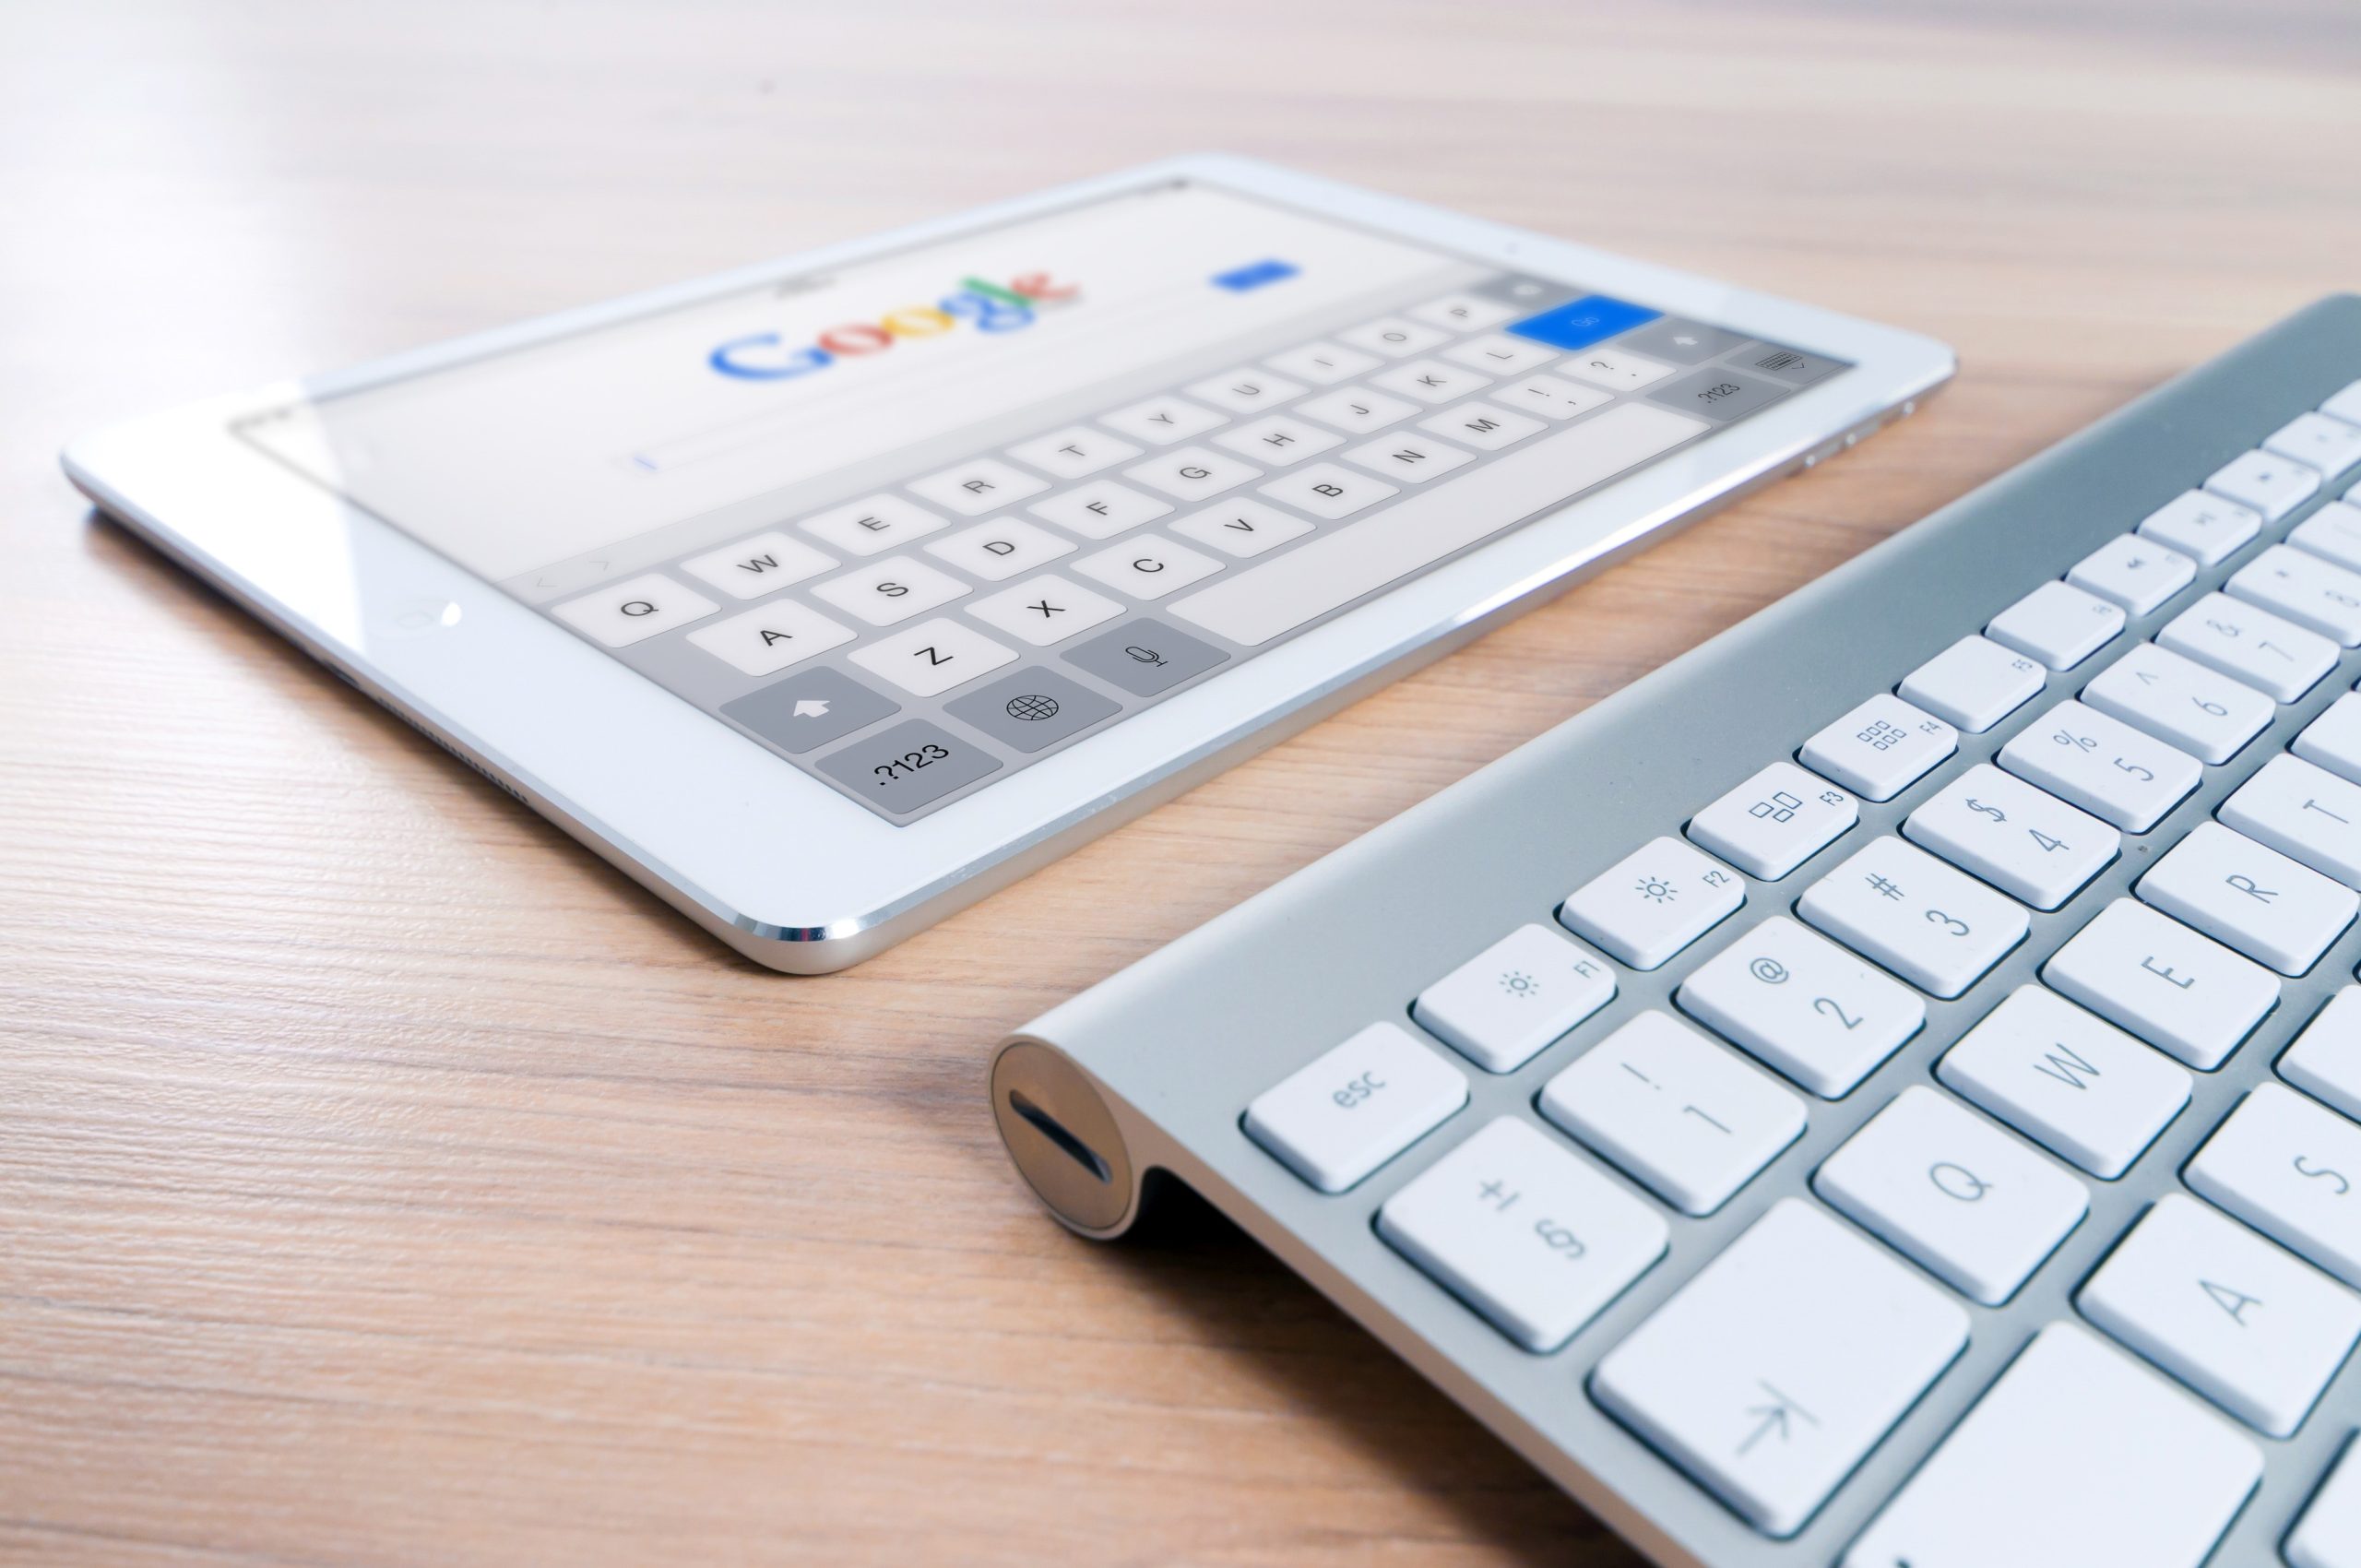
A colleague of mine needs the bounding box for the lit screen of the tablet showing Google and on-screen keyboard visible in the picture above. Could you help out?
[239,182,1848,822]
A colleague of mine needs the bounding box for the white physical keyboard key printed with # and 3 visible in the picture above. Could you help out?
[1795,834,2033,996]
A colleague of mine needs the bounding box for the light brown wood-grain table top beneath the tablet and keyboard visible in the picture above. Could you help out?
[0,0,2361,1565]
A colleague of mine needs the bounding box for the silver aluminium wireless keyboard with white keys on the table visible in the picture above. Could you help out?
[991,295,2361,1568]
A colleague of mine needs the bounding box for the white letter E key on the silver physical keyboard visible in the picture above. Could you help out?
[2042,897,2278,1072]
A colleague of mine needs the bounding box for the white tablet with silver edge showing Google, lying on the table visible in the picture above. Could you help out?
[66,156,1952,973]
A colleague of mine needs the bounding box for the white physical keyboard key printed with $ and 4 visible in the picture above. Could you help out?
[1903,763,2122,909]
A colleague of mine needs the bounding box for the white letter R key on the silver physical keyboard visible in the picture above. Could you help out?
[2132,822,2361,975]
